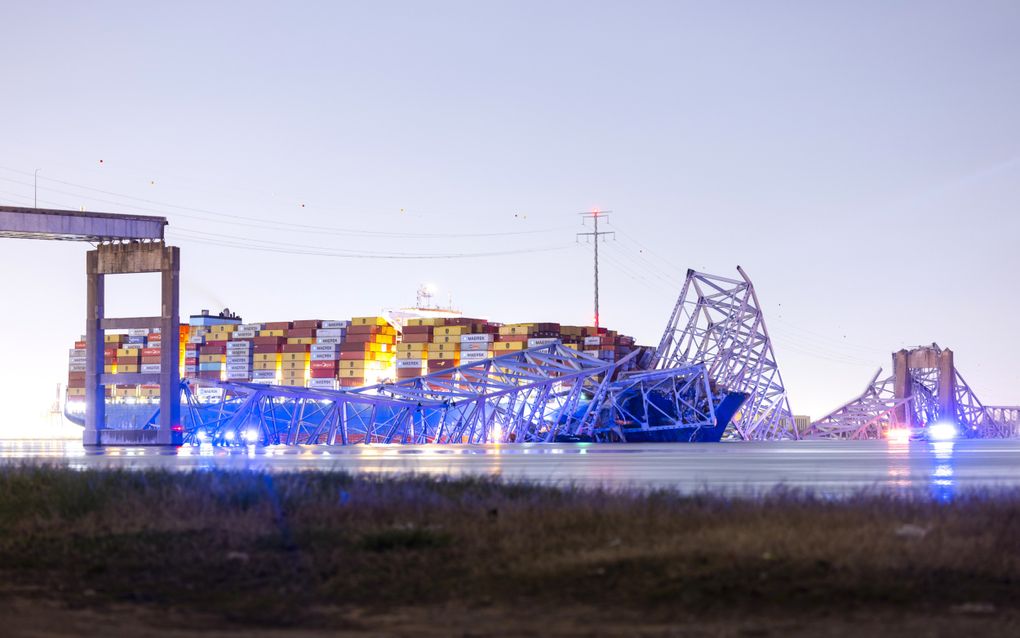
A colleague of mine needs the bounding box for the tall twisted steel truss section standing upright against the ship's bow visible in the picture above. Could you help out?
[652,266,800,439]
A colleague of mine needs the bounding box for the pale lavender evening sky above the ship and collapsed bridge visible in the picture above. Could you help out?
[0,0,1020,434]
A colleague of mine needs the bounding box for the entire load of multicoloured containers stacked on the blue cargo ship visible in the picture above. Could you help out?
[61,315,634,400]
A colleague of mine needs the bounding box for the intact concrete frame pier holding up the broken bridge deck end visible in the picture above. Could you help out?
[82,242,183,446]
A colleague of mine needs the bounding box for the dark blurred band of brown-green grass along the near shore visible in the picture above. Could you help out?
[0,467,1020,635]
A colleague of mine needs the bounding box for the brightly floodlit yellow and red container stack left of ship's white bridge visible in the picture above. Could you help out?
[340,316,397,388]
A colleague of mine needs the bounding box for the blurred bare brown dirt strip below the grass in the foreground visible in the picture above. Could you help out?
[0,597,1020,638]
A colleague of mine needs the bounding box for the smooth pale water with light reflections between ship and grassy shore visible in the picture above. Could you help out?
[0,440,1020,498]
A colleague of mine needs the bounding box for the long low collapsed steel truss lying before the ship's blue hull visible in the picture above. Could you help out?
[179,342,634,445]
